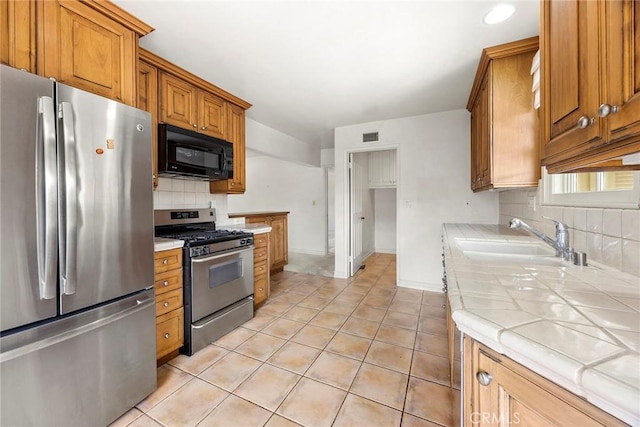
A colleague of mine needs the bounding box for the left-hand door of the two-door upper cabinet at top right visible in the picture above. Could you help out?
[540,0,602,160]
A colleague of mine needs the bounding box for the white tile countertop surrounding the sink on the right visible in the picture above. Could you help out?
[443,224,640,425]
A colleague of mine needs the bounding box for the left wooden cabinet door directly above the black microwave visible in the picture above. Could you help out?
[159,72,198,131]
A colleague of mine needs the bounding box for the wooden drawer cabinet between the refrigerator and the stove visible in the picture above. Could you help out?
[154,248,184,359]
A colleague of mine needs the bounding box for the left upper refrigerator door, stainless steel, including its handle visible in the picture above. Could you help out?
[0,65,58,332]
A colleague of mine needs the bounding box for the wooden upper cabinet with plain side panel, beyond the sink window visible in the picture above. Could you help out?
[467,37,540,191]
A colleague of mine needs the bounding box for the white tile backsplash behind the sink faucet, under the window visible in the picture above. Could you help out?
[499,188,640,276]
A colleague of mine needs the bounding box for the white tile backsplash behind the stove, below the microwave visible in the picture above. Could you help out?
[153,178,229,224]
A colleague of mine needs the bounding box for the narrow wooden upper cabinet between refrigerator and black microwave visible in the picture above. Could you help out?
[138,61,158,190]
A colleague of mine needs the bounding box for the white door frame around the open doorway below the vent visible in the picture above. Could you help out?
[342,144,402,281]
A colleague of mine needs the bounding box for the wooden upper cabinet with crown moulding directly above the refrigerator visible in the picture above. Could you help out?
[37,0,152,106]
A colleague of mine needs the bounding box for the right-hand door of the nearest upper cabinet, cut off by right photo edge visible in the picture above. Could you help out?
[599,0,640,142]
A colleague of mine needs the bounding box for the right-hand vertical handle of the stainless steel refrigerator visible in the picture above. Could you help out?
[58,102,79,295]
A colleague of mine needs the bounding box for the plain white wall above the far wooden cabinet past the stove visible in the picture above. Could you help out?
[227,156,326,255]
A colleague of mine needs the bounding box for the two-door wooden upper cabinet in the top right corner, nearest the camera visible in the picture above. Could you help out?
[540,0,640,173]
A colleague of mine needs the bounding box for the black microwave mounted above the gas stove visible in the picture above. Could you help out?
[158,123,233,181]
